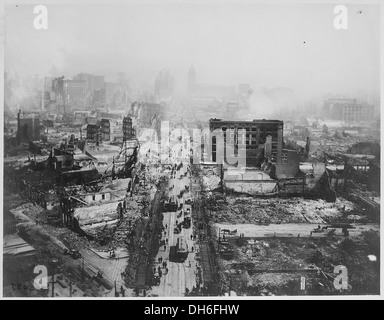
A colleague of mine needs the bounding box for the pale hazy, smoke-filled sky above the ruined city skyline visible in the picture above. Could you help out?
[5,2,380,94]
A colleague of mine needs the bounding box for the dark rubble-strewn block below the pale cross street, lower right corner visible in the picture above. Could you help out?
[216,238,379,295]
